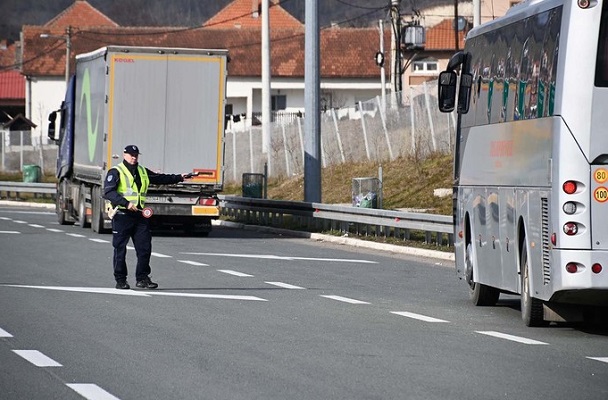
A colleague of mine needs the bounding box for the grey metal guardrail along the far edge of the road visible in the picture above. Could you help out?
[0,182,454,246]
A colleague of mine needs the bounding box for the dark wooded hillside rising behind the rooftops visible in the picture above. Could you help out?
[0,0,453,41]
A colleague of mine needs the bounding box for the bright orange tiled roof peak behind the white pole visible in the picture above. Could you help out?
[203,0,303,29]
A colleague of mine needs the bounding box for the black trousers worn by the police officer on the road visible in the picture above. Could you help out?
[112,211,152,281]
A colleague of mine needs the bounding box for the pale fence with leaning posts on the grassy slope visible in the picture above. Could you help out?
[225,82,455,182]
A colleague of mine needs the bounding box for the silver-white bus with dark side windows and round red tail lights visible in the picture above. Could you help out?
[439,0,608,326]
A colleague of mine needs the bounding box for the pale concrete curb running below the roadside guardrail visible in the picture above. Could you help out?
[0,200,455,261]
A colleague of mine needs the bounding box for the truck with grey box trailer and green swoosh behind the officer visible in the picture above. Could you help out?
[49,46,228,235]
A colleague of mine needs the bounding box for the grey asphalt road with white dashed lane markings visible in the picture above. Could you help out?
[0,205,608,400]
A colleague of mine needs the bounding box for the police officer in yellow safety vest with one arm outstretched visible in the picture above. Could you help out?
[104,144,188,289]
